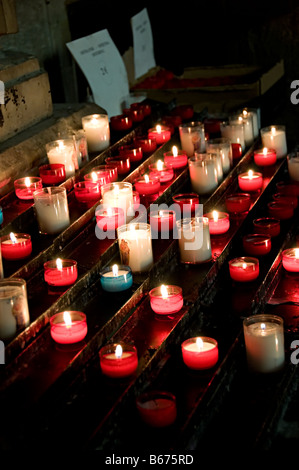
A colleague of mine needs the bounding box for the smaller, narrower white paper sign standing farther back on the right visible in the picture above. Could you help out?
[131,8,156,79]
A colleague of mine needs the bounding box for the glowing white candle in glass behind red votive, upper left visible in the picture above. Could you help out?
[46,138,78,178]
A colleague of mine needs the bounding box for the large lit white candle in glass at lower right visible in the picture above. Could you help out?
[243,314,285,373]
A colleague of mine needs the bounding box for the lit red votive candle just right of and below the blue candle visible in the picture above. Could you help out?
[149,284,184,315]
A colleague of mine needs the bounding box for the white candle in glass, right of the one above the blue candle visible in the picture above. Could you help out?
[176,217,212,264]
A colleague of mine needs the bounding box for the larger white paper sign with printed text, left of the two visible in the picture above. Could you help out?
[66,29,129,116]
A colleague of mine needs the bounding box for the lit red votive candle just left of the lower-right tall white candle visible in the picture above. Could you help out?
[181,336,219,370]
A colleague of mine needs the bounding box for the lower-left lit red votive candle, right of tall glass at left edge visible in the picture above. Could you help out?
[50,311,87,344]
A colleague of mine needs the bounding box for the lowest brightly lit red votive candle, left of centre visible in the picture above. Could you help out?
[100,342,138,378]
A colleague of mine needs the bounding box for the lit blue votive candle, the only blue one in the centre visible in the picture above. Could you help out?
[100,264,133,292]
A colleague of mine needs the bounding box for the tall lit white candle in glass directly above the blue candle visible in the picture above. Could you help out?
[117,222,154,273]
